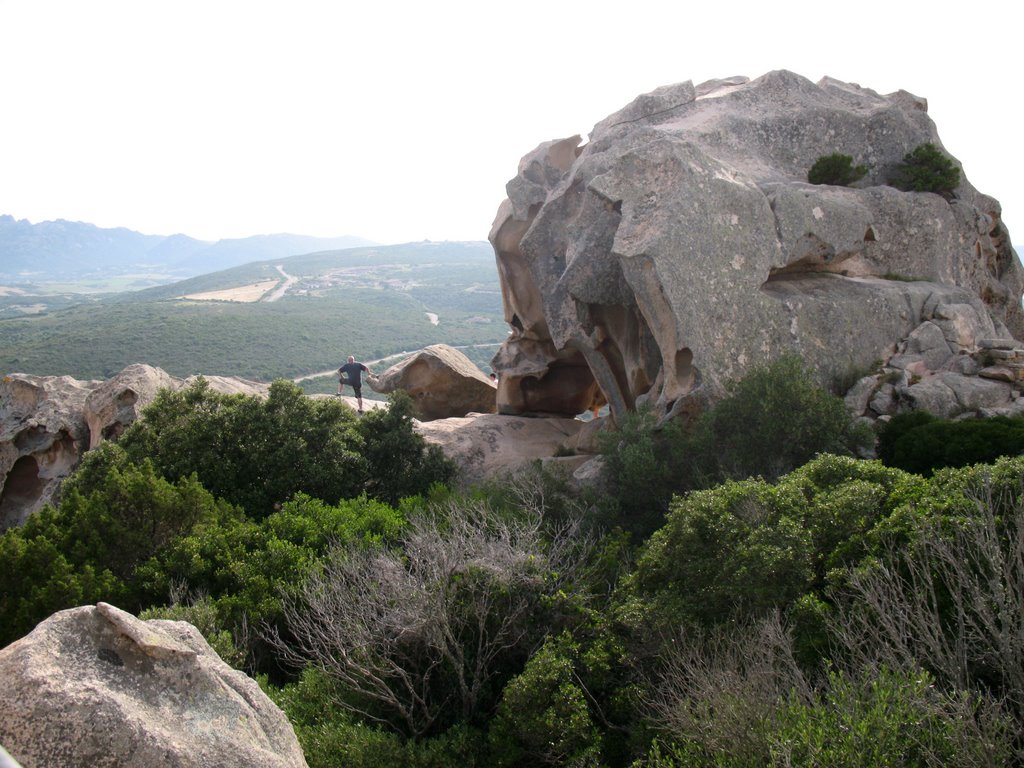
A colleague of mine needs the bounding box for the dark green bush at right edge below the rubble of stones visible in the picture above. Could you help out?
[879,412,1024,475]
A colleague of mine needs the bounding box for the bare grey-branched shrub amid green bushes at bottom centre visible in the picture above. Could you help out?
[272,503,587,738]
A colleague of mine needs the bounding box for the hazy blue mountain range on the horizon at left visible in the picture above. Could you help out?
[0,215,375,285]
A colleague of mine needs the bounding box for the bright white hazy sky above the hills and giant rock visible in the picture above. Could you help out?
[0,0,1024,243]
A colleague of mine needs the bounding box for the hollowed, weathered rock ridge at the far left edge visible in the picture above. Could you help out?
[0,365,268,530]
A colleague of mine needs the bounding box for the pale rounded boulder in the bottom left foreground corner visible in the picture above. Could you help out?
[0,603,306,768]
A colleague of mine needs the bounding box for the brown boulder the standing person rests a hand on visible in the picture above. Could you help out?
[367,344,495,421]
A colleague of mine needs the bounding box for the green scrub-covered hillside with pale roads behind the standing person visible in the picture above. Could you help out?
[0,243,507,380]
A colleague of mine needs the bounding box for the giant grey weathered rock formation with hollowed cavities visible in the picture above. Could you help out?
[490,72,1024,417]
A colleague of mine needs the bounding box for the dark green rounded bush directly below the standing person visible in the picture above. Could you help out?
[119,379,453,519]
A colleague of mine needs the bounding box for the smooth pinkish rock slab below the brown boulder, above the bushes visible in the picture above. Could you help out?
[416,414,584,482]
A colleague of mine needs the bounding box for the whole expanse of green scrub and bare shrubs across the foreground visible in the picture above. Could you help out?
[0,360,1024,768]
